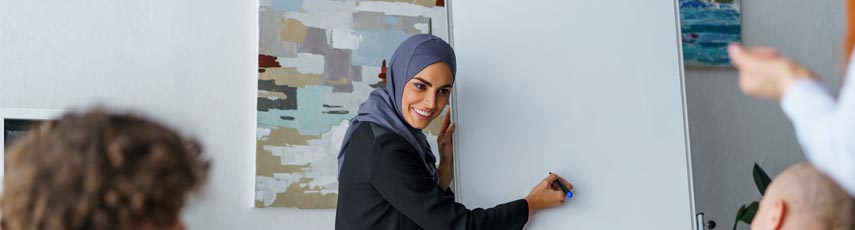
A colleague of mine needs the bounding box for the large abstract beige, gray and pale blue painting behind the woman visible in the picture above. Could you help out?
[255,0,448,209]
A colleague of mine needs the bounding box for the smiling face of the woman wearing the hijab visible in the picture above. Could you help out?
[401,62,453,129]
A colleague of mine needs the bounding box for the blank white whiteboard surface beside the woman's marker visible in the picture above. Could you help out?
[451,0,694,229]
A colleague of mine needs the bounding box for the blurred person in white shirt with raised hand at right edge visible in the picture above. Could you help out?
[728,0,855,196]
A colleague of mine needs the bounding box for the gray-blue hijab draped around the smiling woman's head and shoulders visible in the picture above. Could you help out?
[338,34,457,180]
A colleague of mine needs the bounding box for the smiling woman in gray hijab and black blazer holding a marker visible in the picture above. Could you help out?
[336,34,572,229]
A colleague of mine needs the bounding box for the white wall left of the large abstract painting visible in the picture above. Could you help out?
[0,0,335,229]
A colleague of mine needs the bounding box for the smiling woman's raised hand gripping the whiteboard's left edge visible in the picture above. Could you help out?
[436,108,455,191]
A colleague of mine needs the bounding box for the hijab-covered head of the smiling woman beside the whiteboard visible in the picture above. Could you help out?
[387,34,457,129]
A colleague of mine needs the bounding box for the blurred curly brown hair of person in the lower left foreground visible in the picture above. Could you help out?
[0,109,209,229]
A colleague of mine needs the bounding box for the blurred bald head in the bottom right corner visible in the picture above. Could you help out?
[751,163,855,230]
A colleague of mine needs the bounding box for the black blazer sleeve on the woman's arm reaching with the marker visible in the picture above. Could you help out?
[371,135,528,229]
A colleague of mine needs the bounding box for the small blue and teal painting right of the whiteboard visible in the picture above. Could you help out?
[680,0,742,67]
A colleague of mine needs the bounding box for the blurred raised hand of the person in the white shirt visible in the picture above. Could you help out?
[727,44,816,100]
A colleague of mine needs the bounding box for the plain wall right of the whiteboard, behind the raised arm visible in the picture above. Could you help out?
[685,0,845,228]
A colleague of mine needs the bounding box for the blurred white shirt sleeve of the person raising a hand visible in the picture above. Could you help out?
[781,57,855,196]
